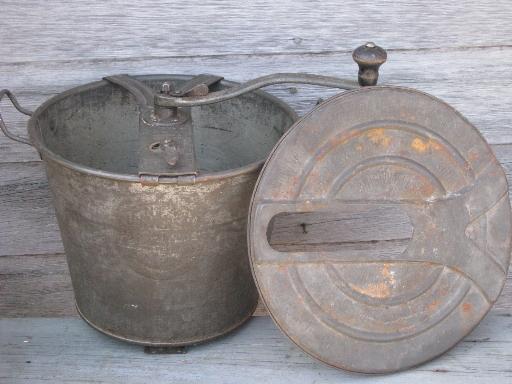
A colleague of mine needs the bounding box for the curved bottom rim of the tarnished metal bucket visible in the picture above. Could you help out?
[75,302,258,348]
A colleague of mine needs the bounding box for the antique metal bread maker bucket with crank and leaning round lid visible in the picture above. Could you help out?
[0,43,511,373]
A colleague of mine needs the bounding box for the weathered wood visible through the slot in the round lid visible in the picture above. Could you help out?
[267,204,414,255]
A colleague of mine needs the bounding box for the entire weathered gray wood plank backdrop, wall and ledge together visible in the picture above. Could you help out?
[0,0,512,383]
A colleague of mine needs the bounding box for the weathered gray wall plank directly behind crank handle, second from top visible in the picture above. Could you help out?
[0,48,512,162]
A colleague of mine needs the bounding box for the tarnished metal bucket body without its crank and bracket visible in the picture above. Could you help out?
[2,75,296,346]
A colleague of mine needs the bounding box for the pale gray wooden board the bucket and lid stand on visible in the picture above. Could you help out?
[0,311,512,384]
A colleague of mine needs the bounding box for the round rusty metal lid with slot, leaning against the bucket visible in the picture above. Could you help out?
[249,87,511,373]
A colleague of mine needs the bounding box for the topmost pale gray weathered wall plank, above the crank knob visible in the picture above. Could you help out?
[0,0,512,62]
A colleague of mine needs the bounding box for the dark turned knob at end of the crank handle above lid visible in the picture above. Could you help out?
[352,42,388,87]
